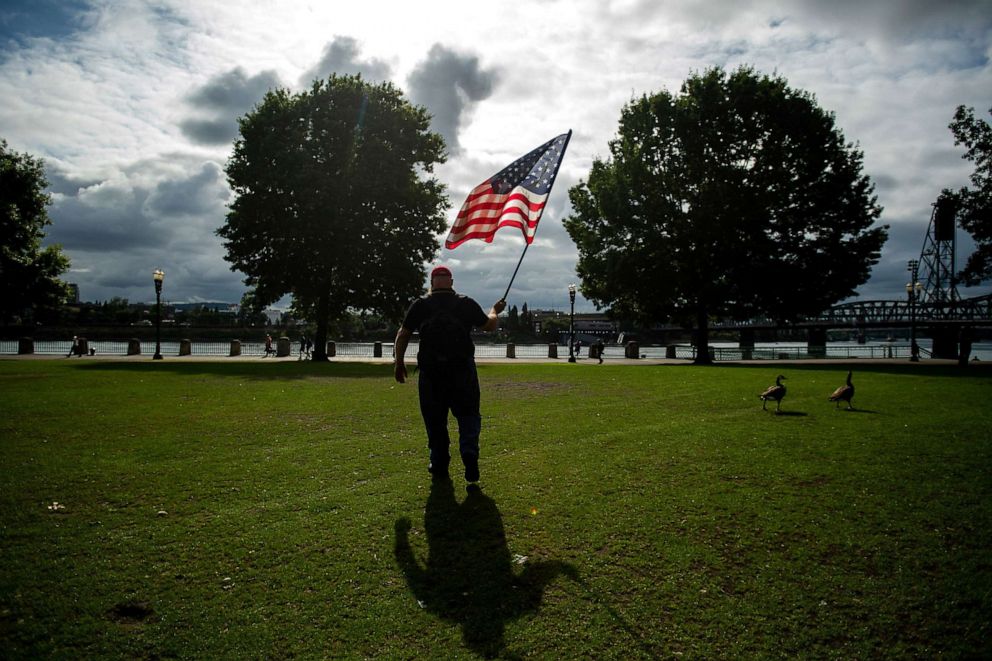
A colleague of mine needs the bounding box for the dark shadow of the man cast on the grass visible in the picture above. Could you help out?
[395,480,578,658]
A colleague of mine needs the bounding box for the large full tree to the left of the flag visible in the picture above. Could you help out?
[217,76,448,360]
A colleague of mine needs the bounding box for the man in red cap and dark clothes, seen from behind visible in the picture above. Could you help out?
[394,266,506,482]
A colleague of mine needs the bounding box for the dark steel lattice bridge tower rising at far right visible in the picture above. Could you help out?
[914,193,961,317]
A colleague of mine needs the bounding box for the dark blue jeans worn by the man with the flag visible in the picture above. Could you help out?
[417,361,482,467]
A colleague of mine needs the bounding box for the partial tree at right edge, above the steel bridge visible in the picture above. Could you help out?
[949,106,992,285]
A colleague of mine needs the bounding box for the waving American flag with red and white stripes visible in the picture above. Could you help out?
[444,131,572,250]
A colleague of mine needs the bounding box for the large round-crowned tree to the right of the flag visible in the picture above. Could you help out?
[565,68,887,362]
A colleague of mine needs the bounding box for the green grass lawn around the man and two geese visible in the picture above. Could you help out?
[0,360,992,659]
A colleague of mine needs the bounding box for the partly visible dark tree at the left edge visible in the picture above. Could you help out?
[0,140,69,324]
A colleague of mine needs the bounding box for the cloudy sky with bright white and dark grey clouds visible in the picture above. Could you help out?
[0,0,992,310]
